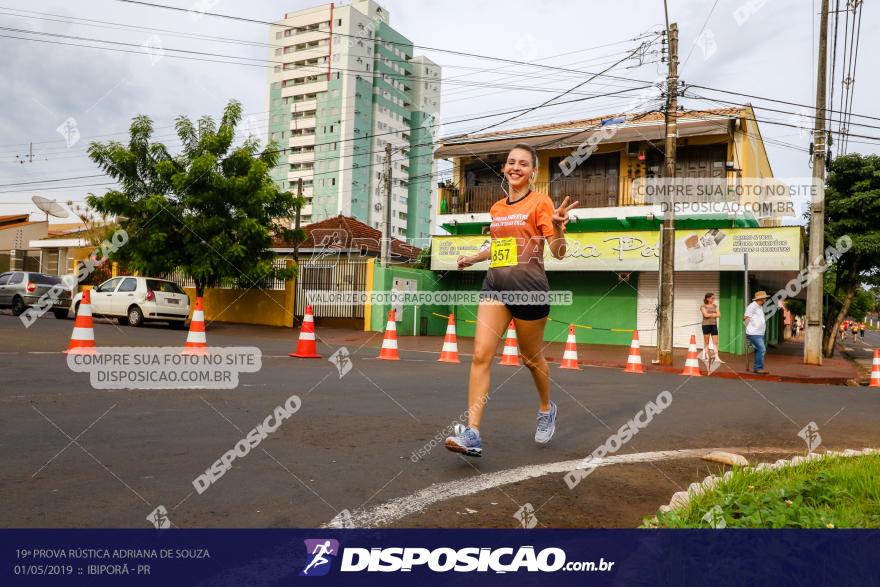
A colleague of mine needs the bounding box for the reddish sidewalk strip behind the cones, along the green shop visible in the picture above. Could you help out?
[306,327,867,385]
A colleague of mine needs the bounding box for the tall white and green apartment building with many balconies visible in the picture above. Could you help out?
[268,0,441,239]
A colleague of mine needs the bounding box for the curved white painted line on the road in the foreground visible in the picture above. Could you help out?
[322,448,792,528]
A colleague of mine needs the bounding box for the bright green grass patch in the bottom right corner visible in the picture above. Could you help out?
[643,454,880,528]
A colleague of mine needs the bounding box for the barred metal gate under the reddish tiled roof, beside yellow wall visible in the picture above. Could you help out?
[295,257,367,318]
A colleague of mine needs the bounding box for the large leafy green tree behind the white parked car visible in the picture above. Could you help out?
[88,100,304,295]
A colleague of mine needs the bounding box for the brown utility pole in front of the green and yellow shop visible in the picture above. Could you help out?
[657,23,678,365]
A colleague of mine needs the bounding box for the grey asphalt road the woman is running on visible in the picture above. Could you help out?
[0,313,880,528]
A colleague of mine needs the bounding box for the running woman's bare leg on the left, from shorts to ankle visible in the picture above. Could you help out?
[468,300,512,430]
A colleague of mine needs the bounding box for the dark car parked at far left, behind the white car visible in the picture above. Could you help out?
[0,271,71,318]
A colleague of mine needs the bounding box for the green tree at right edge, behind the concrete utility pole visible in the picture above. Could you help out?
[822,153,880,357]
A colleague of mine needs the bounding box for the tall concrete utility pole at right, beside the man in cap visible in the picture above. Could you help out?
[804,0,828,365]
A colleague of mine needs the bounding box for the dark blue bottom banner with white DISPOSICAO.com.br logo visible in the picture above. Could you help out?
[0,529,880,587]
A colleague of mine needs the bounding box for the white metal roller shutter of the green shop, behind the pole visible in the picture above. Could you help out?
[636,271,720,348]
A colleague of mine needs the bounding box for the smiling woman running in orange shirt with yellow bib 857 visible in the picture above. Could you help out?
[446,144,578,457]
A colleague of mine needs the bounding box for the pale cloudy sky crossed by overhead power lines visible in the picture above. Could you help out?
[0,0,880,225]
